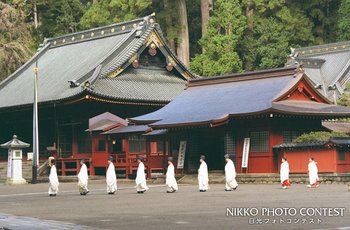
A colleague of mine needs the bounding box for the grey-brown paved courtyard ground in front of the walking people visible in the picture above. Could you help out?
[0,181,350,230]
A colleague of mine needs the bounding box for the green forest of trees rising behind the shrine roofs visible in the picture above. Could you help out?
[0,0,350,80]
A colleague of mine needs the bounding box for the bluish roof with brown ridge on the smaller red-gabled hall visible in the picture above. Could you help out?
[130,68,350,129]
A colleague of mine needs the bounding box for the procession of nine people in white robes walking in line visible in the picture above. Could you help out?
[48,154,319,196]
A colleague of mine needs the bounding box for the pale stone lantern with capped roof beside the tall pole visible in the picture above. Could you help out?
[0,135,30,185]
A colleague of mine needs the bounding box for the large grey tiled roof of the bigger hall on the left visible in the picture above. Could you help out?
[0,16,197,109]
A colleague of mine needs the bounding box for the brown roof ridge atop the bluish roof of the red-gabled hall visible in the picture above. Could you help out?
[188,66,300,87]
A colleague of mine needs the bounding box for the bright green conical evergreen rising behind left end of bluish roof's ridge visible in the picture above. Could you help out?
[191,0,246,76]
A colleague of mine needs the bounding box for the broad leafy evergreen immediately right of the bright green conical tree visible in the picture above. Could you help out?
[239,0,314,70]
